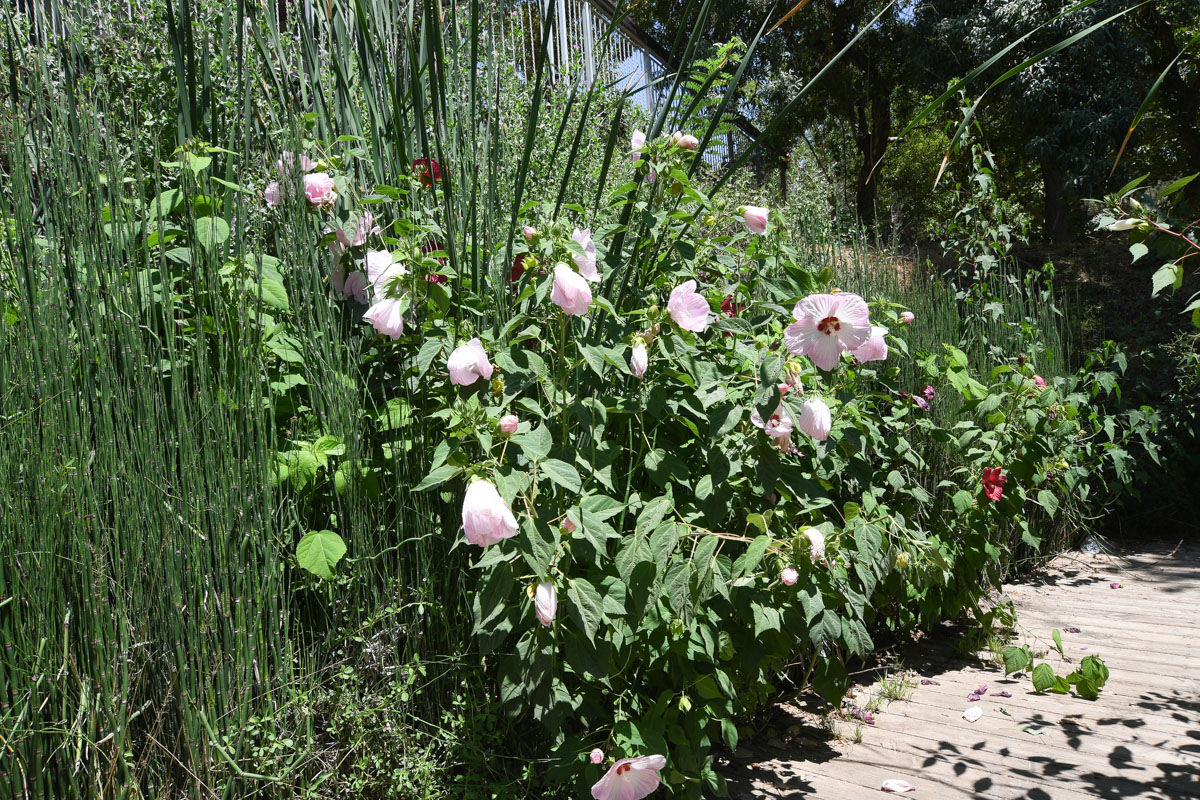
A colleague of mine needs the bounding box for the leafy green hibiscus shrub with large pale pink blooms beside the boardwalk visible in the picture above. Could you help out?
[276,131,1147,796]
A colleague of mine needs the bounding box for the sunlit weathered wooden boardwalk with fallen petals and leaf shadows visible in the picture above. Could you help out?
[727,545,1200,800]
